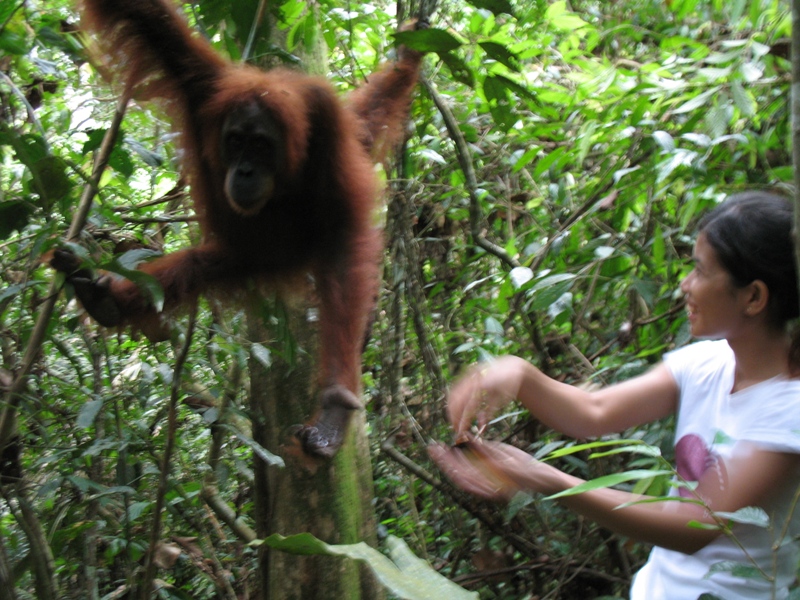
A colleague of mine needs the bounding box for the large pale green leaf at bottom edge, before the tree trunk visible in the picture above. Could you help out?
[262,533,478,600]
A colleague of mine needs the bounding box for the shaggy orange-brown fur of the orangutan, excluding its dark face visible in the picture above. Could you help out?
[72,0,421,456]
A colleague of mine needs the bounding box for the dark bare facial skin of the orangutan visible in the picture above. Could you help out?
[222,101,284,215]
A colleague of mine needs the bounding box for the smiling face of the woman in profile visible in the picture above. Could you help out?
[681,233,748,339]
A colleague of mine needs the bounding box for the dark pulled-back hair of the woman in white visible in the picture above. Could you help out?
[700,191,800,327]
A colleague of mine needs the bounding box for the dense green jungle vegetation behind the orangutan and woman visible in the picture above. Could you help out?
[0,0,792,599]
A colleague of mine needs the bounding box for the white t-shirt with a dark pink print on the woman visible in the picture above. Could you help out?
[630,340,800,600]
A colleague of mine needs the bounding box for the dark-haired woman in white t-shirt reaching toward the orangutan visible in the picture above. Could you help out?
[430,192,800,600]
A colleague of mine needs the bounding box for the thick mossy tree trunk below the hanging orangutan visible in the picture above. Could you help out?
[248,296,382,600]
